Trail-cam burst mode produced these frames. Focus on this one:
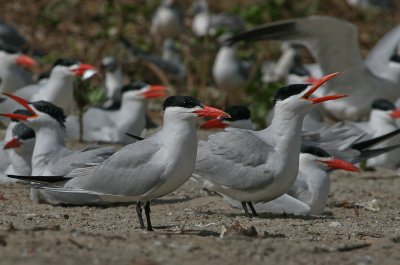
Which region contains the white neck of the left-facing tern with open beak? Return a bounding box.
[32,124,65,174]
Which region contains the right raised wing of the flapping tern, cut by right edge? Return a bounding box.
[366,26,400,81]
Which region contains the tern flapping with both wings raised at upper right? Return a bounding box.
[227,16,400,120]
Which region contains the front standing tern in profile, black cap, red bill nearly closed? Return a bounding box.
[8,96,228,231]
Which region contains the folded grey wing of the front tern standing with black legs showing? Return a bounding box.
[65,139,165,196]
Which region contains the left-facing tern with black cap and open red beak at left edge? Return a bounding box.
[0,94,113,176]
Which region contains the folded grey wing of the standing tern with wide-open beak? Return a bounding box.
[195,128,272,190]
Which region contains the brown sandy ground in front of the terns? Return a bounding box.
[0,163,400,265]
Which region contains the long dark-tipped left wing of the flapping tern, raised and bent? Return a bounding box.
[228,16,365,90]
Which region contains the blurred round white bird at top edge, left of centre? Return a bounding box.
[150,0,183,39]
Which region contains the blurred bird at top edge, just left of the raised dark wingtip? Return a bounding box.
[189,0,245,37]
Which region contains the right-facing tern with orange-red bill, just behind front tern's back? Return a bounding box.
[67,83,167,144]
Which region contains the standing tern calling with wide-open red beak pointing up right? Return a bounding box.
[195,73,345,214]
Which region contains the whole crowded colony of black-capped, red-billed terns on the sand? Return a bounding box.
[0,0,400,231]
